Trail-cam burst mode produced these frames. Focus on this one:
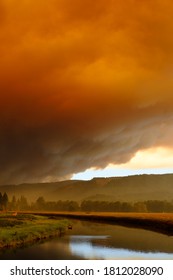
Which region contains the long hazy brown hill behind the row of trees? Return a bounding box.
[0,174,173,202]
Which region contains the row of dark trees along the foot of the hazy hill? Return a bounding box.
[0,193,173,213]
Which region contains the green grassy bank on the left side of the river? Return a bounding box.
[0,214,68,248]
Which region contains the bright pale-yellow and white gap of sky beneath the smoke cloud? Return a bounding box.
[72,147,173,180]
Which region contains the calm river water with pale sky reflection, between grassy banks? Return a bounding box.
[0,220,173,260]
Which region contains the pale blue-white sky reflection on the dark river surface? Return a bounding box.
[69,235,173,259]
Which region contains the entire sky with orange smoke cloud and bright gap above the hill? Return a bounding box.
[0,0,173,184]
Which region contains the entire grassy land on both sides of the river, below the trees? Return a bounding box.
[0,211,173,249]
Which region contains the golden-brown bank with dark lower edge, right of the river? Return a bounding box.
[21,212,173,236]
